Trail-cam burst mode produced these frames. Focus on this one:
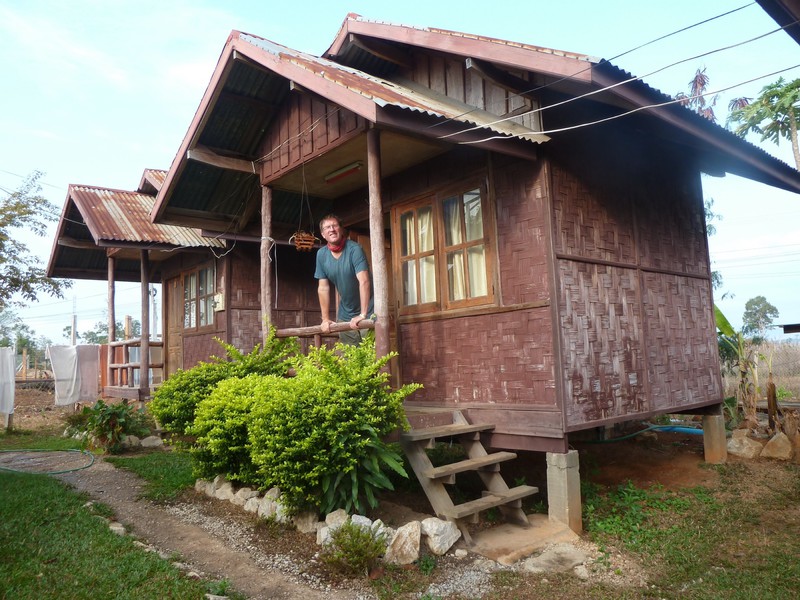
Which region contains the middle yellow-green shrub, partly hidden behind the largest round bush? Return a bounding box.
[189,375,282,483]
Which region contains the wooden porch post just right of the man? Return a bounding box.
[367,128,389,358]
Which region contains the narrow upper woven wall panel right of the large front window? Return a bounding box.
[494,162,550,304]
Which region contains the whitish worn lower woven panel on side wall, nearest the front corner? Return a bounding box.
[558,260,648,426]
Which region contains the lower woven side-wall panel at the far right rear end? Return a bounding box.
[642,273,722,410]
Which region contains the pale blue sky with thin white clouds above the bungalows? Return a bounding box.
[0,0,800,343]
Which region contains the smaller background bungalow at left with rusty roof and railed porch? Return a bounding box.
[47,169,234,400]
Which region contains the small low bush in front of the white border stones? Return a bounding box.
[320,520,387,577]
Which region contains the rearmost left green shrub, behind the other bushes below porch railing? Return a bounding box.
[149,328,299,434]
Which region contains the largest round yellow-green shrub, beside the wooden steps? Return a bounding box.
[249,337,420,512]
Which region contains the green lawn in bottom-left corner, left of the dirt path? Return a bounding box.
[0,472,207,600]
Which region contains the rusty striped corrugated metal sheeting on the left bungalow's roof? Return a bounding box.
[69,185,225,248]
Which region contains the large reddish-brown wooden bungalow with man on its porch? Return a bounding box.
[114,14,800,527]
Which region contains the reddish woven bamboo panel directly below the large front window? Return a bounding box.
[400,308,556,406]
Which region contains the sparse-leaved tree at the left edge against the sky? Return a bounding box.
[0,171,72,310]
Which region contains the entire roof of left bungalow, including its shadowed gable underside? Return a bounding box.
[47,179,225,281]
